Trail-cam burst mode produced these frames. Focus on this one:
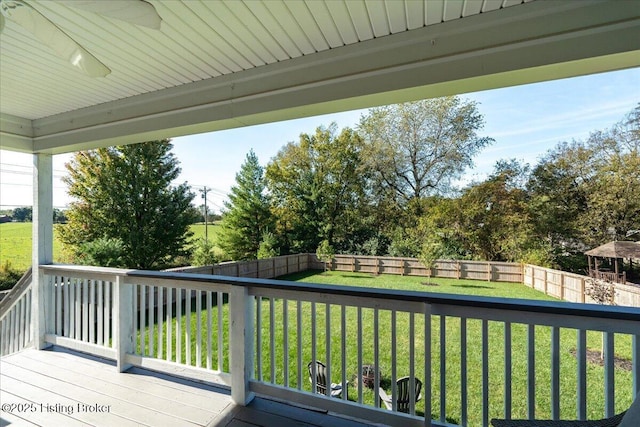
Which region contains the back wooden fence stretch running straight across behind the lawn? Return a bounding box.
[330,255,523,283]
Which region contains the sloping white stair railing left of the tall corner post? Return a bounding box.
[0,269,33,356]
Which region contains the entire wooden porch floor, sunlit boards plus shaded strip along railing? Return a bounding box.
[0,350,378,427]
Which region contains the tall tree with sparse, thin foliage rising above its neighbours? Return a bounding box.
[358,97,493,209]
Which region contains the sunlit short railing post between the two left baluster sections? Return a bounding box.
[113,276,134,372]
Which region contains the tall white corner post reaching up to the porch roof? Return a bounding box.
[31,154,53,350]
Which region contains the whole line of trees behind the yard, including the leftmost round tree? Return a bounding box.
[58,97,640,276]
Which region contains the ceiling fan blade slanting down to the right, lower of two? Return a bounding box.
[1,0,111,77]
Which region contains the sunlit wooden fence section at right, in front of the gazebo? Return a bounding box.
[523,264,640,307]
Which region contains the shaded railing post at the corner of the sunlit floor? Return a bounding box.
[229,286,254,406]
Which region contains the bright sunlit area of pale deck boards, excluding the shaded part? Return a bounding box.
[0,350,231,426]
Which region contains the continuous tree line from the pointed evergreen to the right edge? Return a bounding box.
[219,97,640,271]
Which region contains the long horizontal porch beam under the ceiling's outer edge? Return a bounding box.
[13,0,640,153]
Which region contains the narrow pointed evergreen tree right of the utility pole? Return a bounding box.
[218,150,273,260]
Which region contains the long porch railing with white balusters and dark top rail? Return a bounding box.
[36,266,640,426]
